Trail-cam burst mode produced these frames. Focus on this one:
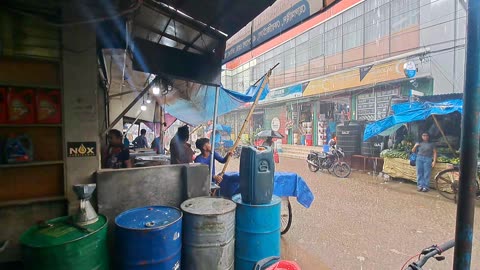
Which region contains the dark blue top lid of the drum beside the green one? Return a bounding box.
[115,206,182,230]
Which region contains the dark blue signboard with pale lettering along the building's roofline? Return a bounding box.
[224,0,323,63]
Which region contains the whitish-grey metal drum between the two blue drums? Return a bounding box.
[181,197,236,270]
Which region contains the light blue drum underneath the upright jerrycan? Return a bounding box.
[232,194,282,270]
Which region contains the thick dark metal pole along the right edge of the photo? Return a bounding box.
[453,1,480,270]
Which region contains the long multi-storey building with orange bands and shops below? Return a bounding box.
[221,0,466,145]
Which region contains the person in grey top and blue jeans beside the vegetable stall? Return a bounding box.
[412,132,437,192]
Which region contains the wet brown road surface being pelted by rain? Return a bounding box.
[222,158,480,270]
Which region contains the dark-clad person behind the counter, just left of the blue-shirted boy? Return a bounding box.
[170,125,194,164]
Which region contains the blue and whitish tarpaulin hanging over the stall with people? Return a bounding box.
[165,77,269,126]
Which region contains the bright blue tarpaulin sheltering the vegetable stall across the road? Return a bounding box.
[363,99,463,141]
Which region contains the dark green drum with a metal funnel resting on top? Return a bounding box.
[20,215,108,270]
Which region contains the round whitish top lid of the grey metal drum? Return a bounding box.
[180,197,237,216]
